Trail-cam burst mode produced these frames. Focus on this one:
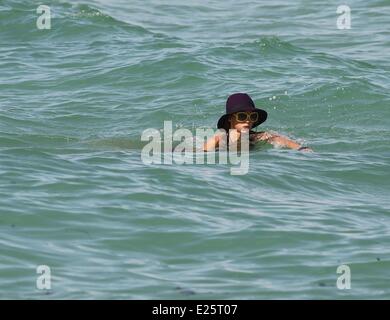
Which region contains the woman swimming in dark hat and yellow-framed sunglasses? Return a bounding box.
[203,93,313,152]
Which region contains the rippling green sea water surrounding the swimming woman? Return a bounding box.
[0,0,390,299]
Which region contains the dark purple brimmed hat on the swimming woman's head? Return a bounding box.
[217,93,267,131]
